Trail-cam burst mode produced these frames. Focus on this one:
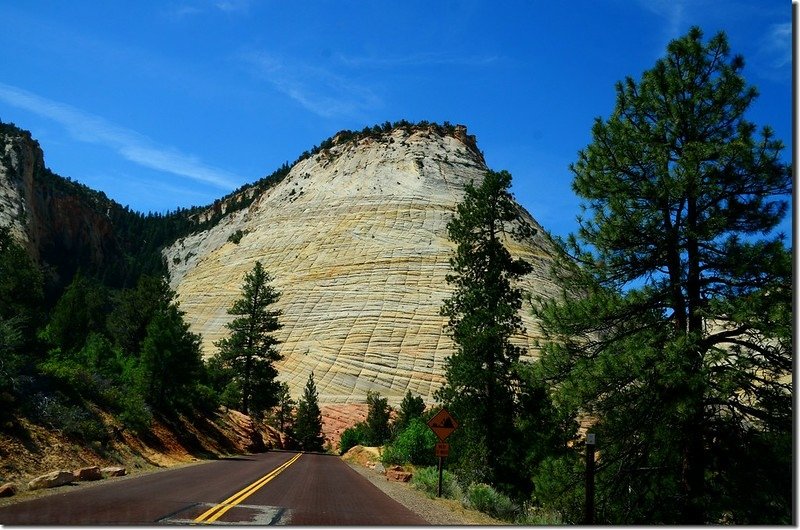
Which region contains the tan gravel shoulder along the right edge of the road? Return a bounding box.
[345,461,508,526]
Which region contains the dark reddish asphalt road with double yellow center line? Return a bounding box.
[0,452,426,525]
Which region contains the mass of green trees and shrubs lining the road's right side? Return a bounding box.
[336,28,793,524]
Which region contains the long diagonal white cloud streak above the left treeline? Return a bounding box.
[0,83,245,189]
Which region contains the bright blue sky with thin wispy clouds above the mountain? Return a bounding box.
[0,0,792,236]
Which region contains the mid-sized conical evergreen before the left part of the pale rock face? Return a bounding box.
[216,261,283,414]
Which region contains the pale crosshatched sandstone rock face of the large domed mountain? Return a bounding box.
[165,125,556,405]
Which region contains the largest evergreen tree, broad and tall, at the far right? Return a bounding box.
[539,28,792,524]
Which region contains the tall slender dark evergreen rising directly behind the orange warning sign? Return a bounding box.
[437,171,532,484]
